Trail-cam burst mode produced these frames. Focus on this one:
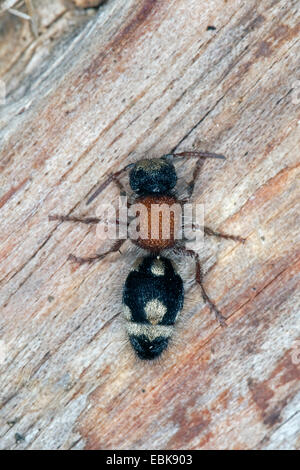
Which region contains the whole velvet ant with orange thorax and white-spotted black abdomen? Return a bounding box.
[49,152,245,360]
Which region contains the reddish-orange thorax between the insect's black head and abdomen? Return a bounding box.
[136,195,181,252]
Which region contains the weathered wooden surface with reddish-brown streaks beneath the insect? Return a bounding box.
[0,0,300,449]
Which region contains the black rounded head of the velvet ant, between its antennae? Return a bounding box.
[129,158,177,195]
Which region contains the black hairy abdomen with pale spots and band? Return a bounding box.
[123,256,184,359]
